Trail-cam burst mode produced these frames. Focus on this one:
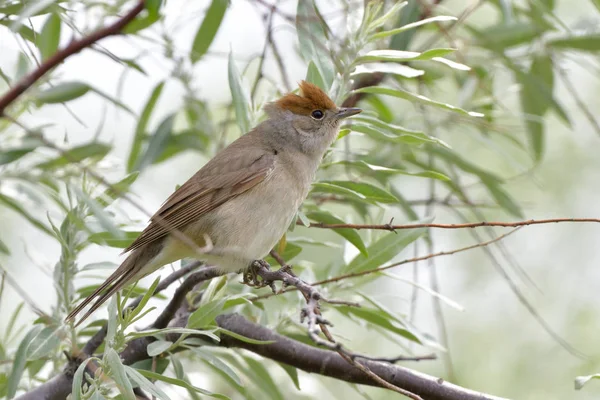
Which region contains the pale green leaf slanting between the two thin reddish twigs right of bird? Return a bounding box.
[344,220,427,272]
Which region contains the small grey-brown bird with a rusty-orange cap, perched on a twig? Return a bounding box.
[66,81,362,324]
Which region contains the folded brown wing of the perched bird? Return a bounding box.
[125,146,275,252]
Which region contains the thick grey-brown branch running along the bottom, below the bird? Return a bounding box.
[18,314,506,400]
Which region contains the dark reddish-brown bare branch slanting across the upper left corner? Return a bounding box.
[0,0,145,117]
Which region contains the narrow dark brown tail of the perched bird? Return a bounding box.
[65,251,147,326]
